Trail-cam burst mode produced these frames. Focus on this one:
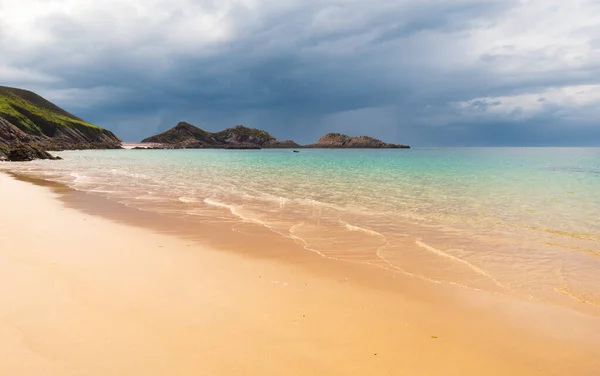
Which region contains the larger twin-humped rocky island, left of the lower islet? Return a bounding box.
[142,122,298,149]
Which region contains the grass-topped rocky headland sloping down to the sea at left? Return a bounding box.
[0,86,121,161]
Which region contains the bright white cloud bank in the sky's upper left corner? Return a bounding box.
[0,0,233,52]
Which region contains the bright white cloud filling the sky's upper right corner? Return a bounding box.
[468,0,600,76]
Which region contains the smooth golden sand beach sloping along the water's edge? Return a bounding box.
[0,174,600,376]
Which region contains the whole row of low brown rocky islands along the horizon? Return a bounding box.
[138,122,410,149]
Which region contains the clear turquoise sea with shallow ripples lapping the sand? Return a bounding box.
[1,148,600,310]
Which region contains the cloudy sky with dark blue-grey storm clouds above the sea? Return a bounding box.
[0,0,600,146]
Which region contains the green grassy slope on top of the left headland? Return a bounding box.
[0,87,101,135]
